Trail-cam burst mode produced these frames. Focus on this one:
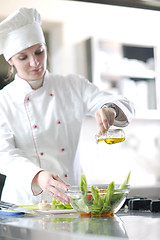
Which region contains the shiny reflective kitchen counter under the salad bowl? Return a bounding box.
[0,210,160,240]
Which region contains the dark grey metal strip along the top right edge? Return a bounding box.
[69,0,160,11]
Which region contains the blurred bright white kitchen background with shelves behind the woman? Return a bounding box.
[0,0,160,191]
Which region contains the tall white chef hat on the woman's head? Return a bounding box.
[0,8,45,61]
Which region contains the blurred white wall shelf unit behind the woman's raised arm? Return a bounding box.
[91,38,160,117]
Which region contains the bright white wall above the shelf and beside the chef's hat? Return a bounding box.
[0,0,160,74]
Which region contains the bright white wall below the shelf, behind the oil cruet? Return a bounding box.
[81,118,160,187]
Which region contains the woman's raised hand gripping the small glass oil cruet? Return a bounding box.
[95,108,116,135]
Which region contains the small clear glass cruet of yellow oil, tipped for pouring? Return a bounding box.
[95,129,125,144]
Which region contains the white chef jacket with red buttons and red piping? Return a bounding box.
[0,71,134,204]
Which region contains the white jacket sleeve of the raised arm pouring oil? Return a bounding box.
[77,77,135,127]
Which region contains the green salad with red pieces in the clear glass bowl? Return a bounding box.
[71,172,130,215]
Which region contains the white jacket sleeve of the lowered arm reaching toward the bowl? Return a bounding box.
[0,114,41,195]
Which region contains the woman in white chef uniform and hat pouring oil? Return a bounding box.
[0,8,134,204]
